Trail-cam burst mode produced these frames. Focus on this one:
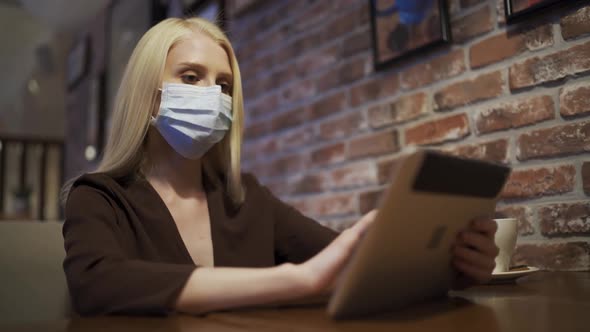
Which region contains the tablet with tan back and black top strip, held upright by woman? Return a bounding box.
[328,150,510,319]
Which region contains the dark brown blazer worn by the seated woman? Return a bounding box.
[63,173,337,315]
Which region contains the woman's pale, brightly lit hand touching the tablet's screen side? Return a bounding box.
[296,210,377,296]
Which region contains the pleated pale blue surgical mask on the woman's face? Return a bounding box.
[152,83,232,159]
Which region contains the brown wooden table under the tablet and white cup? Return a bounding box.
[0,272,590,332]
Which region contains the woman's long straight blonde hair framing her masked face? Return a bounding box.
[62,17,244,204]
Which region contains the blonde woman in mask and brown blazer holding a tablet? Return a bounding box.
[63,18,497,314]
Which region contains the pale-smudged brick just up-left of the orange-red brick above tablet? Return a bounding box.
[369,93,430,128]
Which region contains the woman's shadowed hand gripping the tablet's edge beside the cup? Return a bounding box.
[452,218,498,289]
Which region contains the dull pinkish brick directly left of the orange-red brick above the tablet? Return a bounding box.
[348,130,399,159]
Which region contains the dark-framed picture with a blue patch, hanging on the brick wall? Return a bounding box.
[369,0,452,70]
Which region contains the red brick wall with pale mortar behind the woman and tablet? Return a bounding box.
[230,0,590,270]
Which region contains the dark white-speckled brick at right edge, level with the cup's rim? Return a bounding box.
[539,202,590,236]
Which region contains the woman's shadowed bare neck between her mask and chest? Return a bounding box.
[144,129,204,197]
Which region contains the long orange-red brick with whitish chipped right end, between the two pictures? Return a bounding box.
[469,24,553,68]
